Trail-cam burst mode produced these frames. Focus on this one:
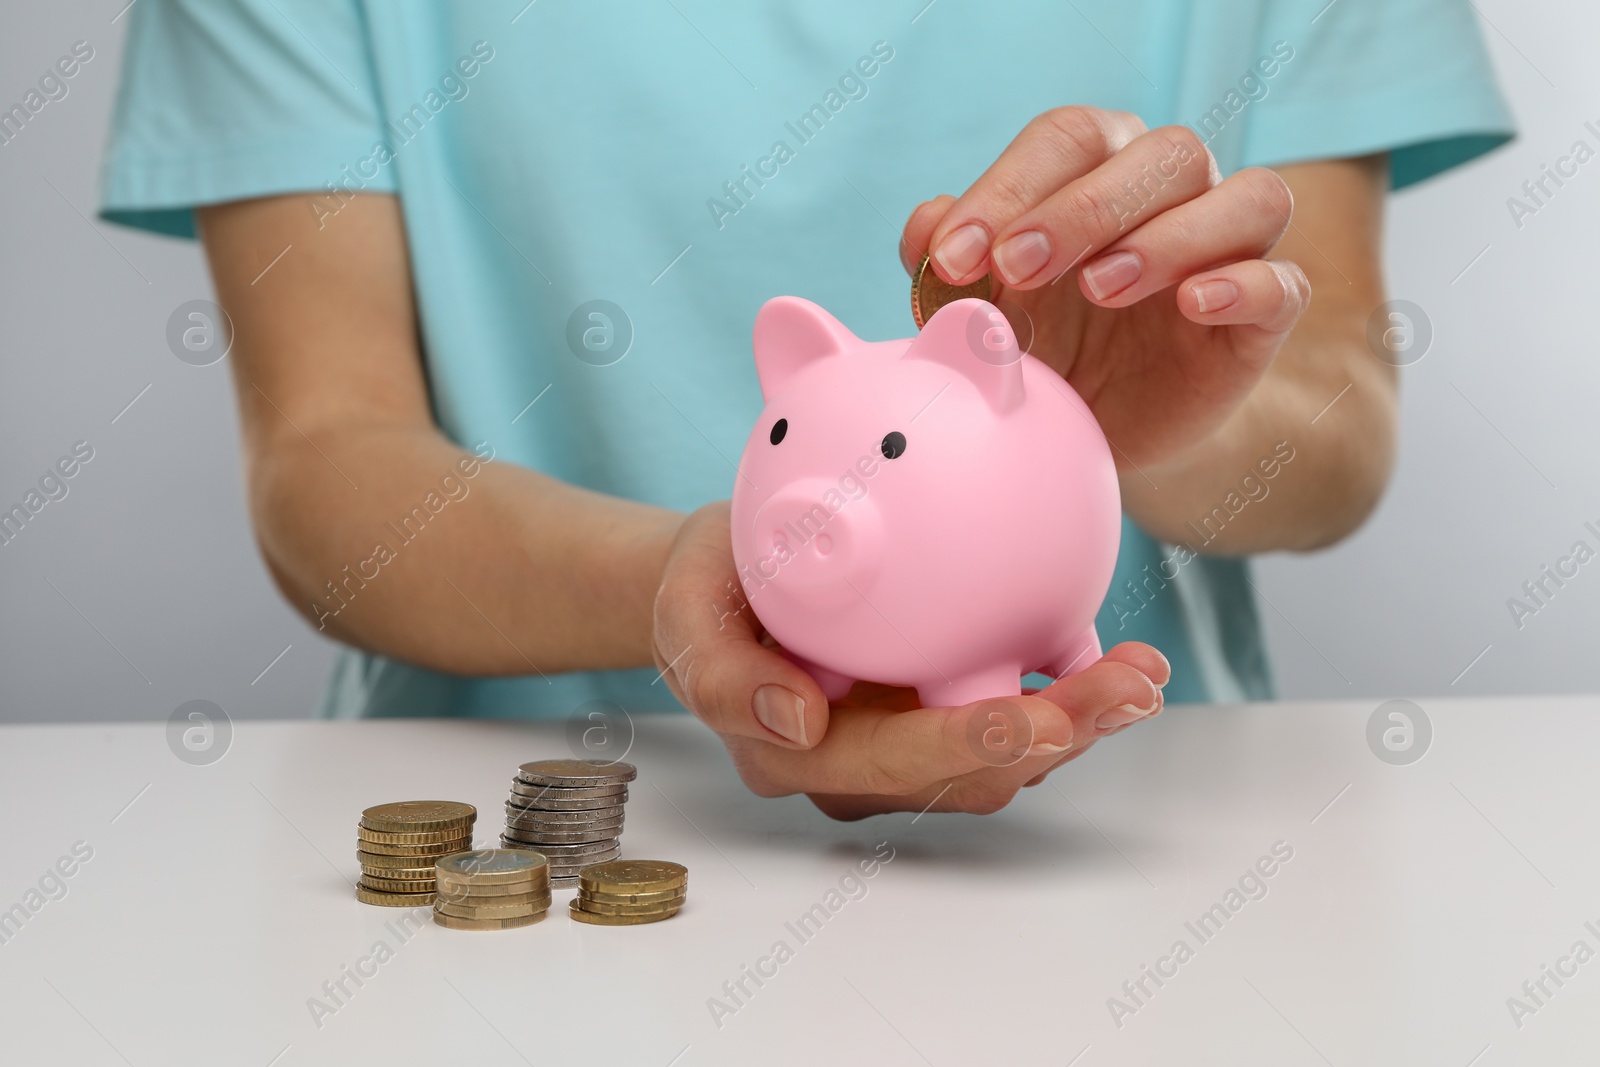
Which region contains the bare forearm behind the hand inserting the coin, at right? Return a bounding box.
[1122,328,1397,555]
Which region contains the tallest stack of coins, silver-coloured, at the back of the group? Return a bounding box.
[501,760,638,889]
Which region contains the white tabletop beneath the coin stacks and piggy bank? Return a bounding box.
[0,697,1600,1067]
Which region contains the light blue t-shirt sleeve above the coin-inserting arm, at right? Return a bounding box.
[1190,0,1515,189]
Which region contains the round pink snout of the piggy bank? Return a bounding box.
[752,478,883,600]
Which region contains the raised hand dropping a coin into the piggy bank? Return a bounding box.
[901,107,1310,469]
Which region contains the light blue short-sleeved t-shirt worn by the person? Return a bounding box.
[101,0,1510,717]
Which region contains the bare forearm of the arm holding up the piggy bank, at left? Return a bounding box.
[242,422,683,675]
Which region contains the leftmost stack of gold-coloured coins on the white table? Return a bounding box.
[355,800,478,907]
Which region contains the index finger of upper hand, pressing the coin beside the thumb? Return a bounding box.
[930,107,1144,285]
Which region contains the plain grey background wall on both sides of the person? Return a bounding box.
[0,0,1600,721]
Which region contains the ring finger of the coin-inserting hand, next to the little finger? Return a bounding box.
[1078,168,1294,307]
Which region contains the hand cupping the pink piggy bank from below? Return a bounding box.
[653,502,1171,819]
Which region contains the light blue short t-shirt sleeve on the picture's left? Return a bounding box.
[99,0,395,237]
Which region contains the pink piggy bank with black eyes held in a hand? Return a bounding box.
[733,296,1122,707]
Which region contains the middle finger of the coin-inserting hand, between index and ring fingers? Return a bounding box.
[994,126,1221,290]
